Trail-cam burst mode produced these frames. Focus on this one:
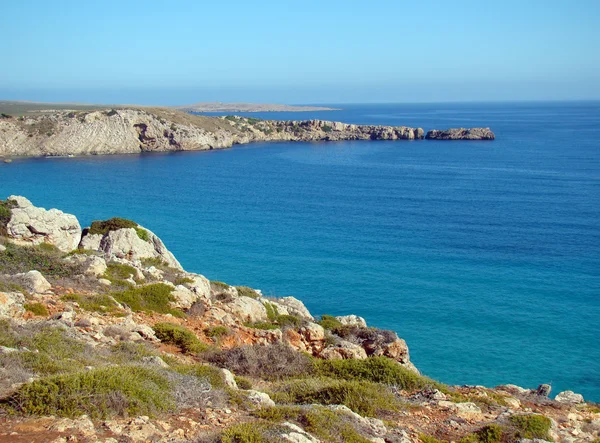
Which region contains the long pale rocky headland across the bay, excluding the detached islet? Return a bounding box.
[0,108,423,157]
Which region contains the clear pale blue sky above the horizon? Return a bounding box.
[0,0,600,105]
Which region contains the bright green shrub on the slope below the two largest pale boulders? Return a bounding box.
[112,283,180,317]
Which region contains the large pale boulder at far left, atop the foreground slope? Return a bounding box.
[6,195,81,252]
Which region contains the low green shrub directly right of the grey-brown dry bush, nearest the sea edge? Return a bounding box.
[313,357,440,391]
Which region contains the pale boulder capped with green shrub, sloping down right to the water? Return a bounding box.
[79,226,183,270]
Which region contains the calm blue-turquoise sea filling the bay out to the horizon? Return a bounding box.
[0,103,600,401]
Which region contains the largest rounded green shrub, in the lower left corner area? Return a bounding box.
[4,366,174,418]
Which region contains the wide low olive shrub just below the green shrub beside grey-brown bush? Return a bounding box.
[273,378,397,417]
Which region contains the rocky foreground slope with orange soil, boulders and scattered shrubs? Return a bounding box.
[0,196,600,443]
